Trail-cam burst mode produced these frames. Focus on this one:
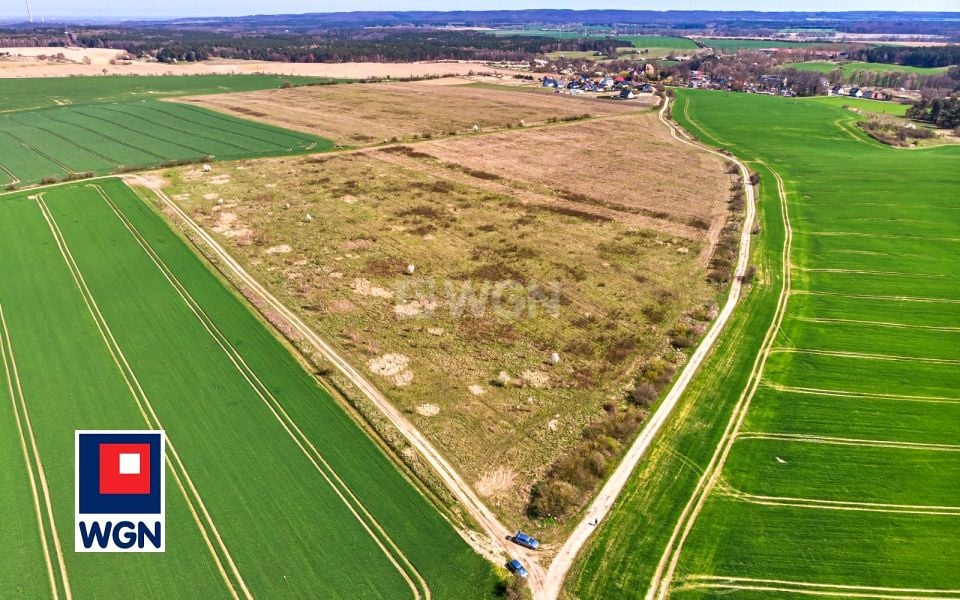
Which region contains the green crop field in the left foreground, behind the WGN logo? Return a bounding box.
[0,178,496,598]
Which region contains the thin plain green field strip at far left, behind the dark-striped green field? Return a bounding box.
[0,75,338,113]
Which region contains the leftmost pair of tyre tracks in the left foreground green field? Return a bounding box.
[0,306,73,600]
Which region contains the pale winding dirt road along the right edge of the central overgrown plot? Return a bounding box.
[533,101,756,599]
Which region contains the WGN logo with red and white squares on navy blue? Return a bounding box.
[74,431,165,552]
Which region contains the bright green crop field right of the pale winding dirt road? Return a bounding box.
[568,90,960,598]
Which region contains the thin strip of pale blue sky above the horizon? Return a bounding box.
[9,0,960,17]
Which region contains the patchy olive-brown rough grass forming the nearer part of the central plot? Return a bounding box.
[163,138,722,537]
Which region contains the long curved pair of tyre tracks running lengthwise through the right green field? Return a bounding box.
[646,162,793,600]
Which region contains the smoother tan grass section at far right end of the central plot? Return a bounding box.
[417,114,730,237]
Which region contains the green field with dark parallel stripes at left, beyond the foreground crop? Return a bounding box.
[0,100,331,184]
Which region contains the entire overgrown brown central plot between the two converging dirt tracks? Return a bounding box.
[163,104,731,535]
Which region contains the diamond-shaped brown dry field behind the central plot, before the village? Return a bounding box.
[179,82,644,146]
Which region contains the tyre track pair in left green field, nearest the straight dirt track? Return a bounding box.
[90,185,431,600]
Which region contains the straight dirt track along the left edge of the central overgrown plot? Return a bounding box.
[128,176,544,589]
